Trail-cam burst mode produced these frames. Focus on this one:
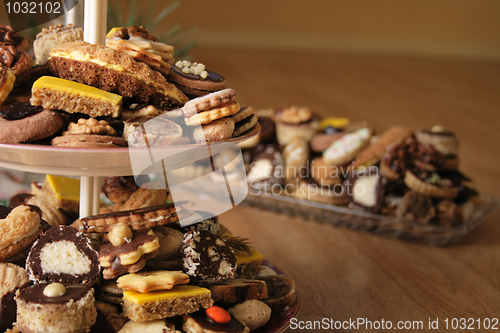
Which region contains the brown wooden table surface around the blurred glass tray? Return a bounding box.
[193,48,500,332]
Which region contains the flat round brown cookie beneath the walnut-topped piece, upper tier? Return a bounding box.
[52,134,127,148]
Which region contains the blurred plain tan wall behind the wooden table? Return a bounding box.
[163,0,500,60]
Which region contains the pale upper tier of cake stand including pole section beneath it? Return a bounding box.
[0,123,260,217]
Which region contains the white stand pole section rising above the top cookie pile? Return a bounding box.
[83,0,108,45]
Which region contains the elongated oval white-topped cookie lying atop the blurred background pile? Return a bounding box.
[323,127,372,166]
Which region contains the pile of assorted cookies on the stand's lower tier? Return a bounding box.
[0,175,297,333]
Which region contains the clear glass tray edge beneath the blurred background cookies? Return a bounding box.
[243,190,500,246]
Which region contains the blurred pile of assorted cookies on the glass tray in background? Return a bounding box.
[240,106,479,227]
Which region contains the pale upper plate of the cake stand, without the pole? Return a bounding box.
[0,123,260,177]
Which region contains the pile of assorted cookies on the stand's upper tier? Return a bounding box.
[0,24,257,148]
